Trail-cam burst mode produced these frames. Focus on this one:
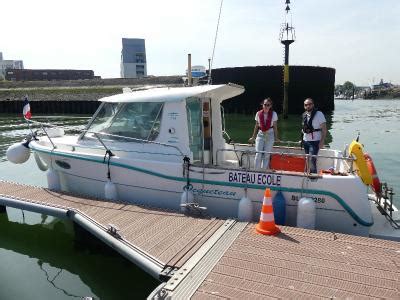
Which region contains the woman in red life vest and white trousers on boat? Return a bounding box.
[249,98,279,169]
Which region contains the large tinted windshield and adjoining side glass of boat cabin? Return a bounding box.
[86,102,163,141]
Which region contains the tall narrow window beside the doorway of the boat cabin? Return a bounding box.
[186,98,203,161]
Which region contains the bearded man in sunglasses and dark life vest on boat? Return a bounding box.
[302,98,326,173]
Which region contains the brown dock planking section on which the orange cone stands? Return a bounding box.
[193,224,400,299]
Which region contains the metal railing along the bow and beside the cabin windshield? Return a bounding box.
[26,119,185,158]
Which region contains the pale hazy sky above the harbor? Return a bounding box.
[0,0,400,86]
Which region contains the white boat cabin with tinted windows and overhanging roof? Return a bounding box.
[80,84,244,164]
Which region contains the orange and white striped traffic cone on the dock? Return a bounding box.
[256,188,281,235]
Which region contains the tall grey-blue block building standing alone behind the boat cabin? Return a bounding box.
[121,38,147,78]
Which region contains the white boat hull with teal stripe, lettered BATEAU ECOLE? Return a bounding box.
[34,147,373,236]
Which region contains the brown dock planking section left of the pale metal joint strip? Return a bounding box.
[0,181,224,268]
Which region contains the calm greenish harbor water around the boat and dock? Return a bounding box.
[0,100,400,299]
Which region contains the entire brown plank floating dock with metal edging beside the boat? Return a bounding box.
[0,181,400,299]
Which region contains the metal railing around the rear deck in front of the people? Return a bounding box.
[216,148,355,173]
